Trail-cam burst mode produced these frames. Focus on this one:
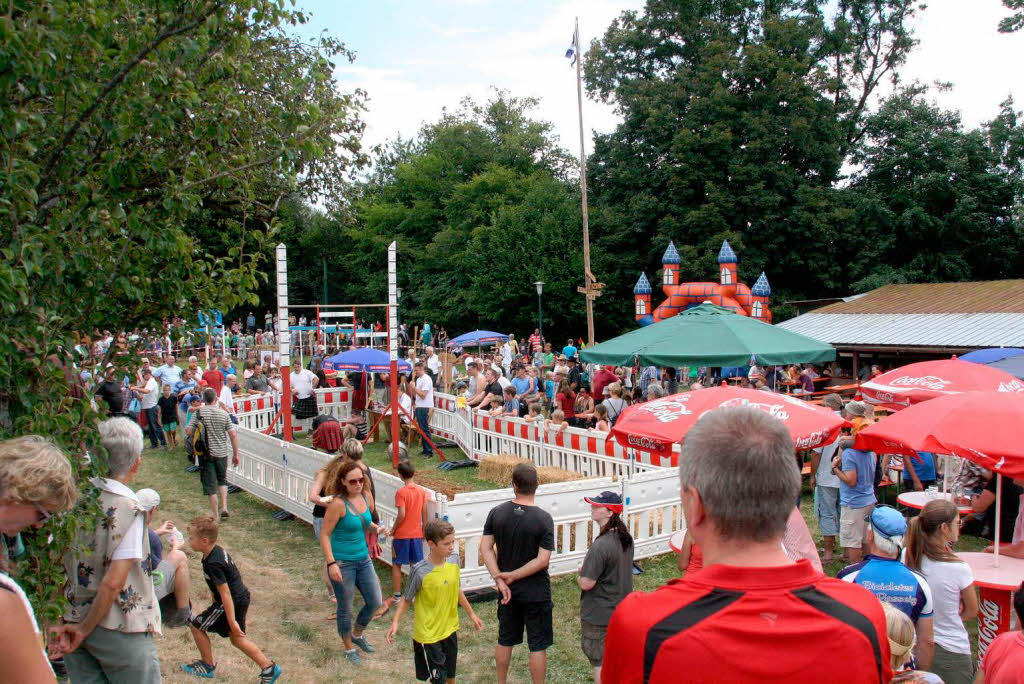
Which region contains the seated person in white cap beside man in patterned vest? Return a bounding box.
[135,488,191,627]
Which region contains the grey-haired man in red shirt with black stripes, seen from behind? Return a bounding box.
[601,407,892,684]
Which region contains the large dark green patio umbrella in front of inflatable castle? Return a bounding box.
[580,302,836,368]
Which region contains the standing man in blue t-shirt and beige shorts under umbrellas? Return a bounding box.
[831,438,878,563]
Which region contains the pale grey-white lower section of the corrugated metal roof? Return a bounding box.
[779,313,1024,347]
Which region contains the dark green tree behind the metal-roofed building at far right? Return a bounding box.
[849,88,1024,291]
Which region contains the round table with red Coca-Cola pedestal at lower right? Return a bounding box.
[956,545,1024,660]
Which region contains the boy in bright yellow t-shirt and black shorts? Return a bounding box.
[386,520,483,684]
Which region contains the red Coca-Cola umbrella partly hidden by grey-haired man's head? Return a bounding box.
[611,387,849,456]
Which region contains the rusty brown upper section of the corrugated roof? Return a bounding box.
[815,281,1024,313]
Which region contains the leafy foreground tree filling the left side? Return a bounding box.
[0,0,362,619]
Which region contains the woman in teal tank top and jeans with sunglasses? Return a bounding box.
[321,462,384,665]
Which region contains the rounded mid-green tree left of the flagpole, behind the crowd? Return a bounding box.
[337,92,583,333]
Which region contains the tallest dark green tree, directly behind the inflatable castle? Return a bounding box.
[585,0,918,329]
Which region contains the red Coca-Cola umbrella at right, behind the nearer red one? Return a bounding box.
[860,358,1024,411]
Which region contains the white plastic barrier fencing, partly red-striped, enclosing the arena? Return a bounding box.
[228,388,684,589]
